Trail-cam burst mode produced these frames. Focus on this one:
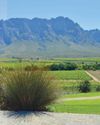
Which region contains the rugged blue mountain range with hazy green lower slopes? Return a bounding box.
[0,16,100,58]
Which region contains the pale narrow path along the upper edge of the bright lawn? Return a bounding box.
[59,96,100,102]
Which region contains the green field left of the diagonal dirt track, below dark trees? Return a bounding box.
[50,70,92,80]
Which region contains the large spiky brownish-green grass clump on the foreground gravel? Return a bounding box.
[0,70,58,111]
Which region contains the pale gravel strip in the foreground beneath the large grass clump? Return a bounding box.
[0,111,100,125]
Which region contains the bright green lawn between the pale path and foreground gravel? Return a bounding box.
[49,99,100,114]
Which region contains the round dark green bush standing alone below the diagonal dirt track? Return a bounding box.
[78,80,91,93]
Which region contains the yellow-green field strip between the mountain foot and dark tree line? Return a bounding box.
[0,57,100,68]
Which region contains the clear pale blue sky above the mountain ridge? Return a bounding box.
[0,0,100,30]
